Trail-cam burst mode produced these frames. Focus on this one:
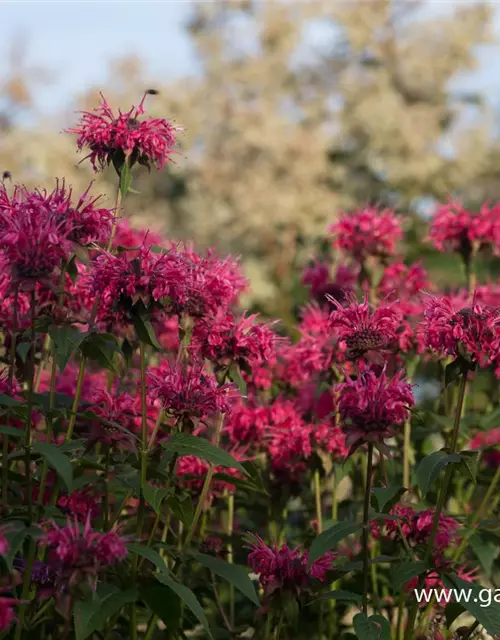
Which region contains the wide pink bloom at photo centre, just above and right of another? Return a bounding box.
[190,312,277,367]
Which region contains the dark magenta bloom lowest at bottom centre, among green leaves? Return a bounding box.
[248,535,335,598]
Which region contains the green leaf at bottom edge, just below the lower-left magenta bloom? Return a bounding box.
[74,587,139,640]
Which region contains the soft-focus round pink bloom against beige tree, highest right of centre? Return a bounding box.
[330,207,403,262]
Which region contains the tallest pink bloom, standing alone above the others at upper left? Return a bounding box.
[67,91,181,171]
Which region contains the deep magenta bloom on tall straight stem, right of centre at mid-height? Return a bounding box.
[335,369,415,451]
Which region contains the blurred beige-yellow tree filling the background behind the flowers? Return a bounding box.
[0,0,500,314]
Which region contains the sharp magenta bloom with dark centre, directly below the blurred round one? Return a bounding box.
[330,296,401,359]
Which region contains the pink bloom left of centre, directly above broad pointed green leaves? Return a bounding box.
[147,362,234,417]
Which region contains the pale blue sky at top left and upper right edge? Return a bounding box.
[0,0,500,114]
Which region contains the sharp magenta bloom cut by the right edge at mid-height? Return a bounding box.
[423,295,500,367]
